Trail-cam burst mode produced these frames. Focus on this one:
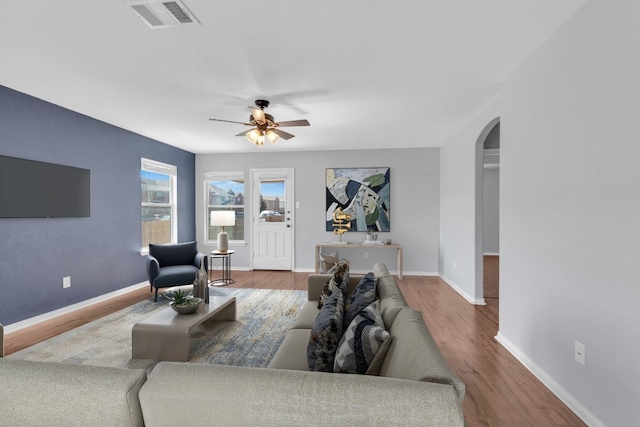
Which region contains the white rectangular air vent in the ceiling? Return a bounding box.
[124,0,200,29]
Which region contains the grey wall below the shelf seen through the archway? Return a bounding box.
[482,165,500,255]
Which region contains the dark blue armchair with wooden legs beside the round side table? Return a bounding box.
[147,242,209,301]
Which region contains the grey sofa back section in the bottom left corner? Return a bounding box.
[0,358,147,427]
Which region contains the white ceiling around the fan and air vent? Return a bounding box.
[0,0,586,153]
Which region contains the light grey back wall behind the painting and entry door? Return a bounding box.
[196,147,440,275]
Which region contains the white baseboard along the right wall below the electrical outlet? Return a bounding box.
[495,331,606,427]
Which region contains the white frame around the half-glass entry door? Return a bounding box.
[251,168,296,271]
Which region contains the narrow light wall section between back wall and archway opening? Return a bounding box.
[440,101,499,304]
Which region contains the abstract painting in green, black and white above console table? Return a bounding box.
[325,167,391,232]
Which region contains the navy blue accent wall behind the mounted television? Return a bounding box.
[0,86,195,325]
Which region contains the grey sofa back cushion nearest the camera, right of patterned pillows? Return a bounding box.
[380,307,465,402]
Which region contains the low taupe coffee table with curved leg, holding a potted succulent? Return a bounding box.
[131,296,236,362]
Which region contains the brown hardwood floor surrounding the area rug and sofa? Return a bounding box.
[5,263,585,427]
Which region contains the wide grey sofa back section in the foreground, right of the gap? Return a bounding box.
[140,362,464,427]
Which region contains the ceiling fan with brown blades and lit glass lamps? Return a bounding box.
[209,99,310,147]
